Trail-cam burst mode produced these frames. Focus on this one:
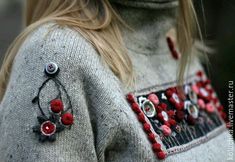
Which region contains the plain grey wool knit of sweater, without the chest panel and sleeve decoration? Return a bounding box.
[0,1,234,162]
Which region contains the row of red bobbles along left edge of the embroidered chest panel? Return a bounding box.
[127,93,166,159]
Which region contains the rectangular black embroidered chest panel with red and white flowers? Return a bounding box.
[127,71,226,159]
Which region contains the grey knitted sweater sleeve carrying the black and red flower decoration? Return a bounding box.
[0,22,97,162]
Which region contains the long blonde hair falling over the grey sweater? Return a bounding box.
[0,0,196,101]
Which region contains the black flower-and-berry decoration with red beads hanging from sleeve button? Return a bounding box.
[32,62,74,142]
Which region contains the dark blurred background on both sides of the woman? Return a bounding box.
[0,0,235,132]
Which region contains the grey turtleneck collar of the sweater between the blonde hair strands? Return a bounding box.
[112,0,178,55]
